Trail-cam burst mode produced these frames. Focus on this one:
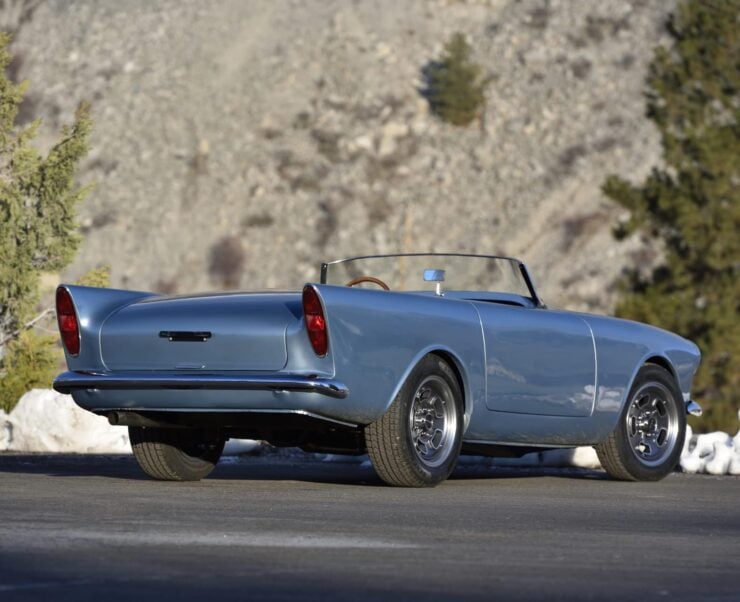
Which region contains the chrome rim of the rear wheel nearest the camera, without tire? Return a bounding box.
[409,374,458,468]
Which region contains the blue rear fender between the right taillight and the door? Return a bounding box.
[315,285,485,424]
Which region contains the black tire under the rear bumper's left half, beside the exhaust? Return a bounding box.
[128,426,225,481]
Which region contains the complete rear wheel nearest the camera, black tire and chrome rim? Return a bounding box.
[365,355,463,487]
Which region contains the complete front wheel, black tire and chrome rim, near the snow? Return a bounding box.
[596,364,686,481]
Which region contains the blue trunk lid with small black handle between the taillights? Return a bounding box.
[100,293,302,371]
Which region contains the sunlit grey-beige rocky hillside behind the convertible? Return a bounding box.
[8,0,673,311]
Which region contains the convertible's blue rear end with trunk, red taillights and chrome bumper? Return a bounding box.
[54,285,351,423]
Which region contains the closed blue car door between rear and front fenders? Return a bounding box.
[475,302,596,416]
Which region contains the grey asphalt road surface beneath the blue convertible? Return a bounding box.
[0,454,740,602]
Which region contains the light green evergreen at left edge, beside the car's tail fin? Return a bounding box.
[0,33,91,408]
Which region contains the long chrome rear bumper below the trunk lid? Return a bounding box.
[54,372,349,399]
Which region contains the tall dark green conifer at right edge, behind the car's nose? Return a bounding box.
[603,0,740,432]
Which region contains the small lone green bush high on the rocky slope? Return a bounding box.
[424,32,486,125]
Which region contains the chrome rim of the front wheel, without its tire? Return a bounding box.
[625,382,680,466]
